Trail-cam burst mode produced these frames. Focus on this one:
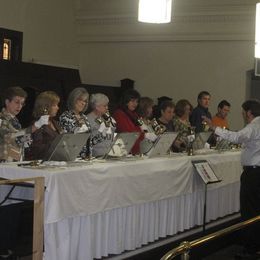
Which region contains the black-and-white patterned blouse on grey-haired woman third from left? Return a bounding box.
[59,110,92,158]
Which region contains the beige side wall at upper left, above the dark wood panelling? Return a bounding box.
[0,0,79,67]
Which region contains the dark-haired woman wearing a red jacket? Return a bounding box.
[113,89,144,155]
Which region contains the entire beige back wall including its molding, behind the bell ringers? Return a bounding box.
[76,0,257,129]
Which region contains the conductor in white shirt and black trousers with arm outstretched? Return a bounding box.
[208,100,260,259]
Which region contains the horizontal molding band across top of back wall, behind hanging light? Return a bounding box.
[75,3,255,43]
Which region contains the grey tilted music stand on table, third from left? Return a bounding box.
[142,132,178,158]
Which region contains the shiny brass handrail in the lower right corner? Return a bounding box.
[161,215,260,260]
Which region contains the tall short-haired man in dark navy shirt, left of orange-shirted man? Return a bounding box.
[190,91,211,133]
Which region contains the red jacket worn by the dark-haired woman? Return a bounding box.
[113,108,144,154]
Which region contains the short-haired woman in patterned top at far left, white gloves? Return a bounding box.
[0,87,48,162]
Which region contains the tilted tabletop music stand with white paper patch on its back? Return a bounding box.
[104,132,140,159]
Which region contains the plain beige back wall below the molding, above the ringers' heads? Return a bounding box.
[80,41,253,129]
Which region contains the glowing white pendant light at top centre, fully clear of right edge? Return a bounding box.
[138,0,172,23]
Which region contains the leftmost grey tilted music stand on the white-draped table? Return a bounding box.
[43,133,90,162]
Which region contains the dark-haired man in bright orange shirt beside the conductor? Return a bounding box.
[212,100,231,129]
